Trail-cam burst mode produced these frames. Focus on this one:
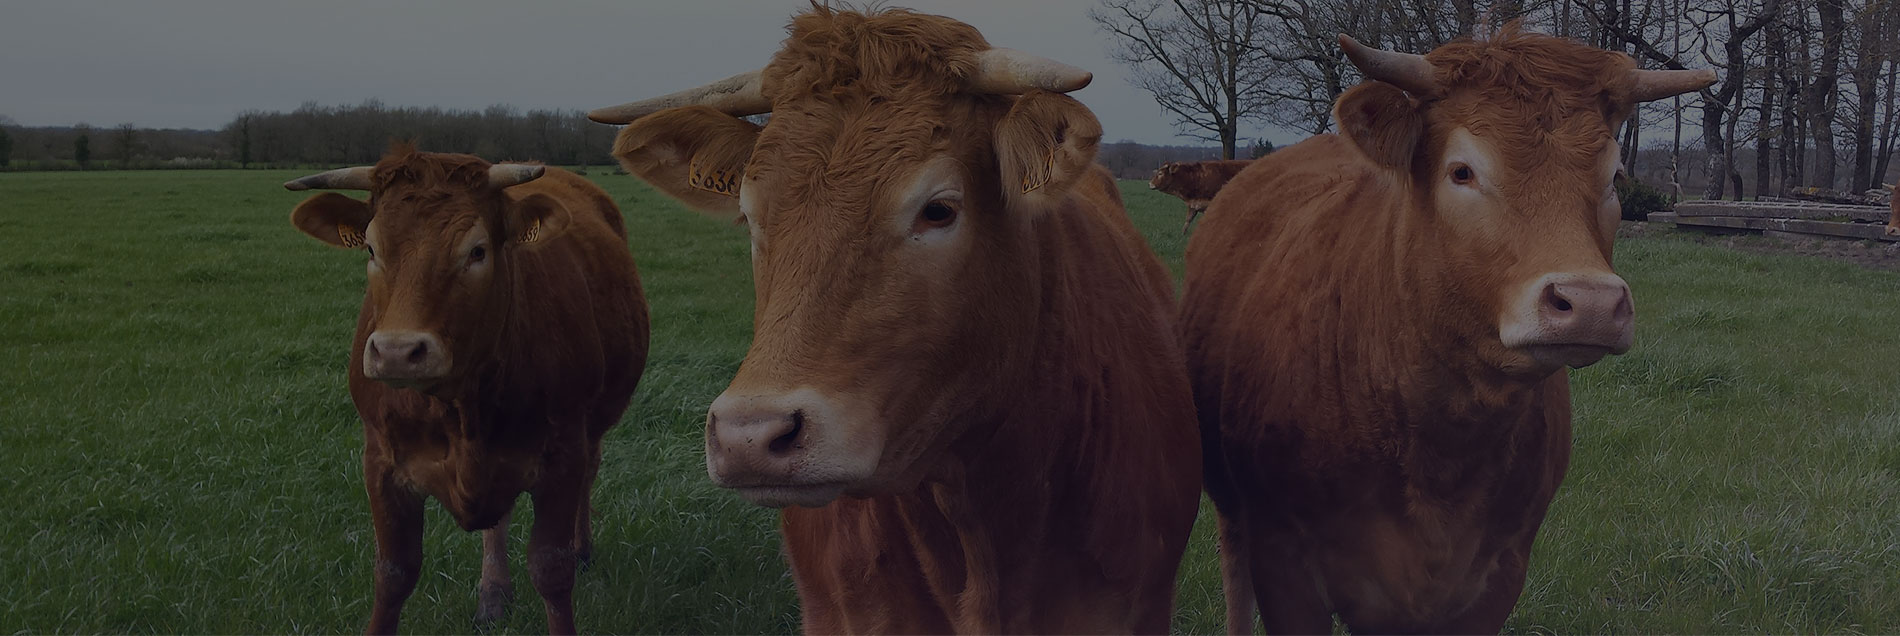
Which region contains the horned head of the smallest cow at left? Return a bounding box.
[283,146,568,391]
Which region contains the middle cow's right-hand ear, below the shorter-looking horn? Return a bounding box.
[996,91,1102,203]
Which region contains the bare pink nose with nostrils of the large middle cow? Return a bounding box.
[707,393,815,488]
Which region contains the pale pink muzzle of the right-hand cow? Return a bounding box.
[1497,273,1636,368]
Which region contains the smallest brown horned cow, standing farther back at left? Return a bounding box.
[285,146,648,632]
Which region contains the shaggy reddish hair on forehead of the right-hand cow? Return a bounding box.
[1425,21,1636,179]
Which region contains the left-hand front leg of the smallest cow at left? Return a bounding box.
[363,463,422,634]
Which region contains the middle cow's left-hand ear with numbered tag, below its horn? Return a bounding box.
[614,106,758,220]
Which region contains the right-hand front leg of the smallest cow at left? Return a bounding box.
[528,473,583,634]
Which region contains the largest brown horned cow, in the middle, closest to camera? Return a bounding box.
[591,8,1201,634]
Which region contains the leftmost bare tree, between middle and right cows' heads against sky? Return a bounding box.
[1089,0,1271,159]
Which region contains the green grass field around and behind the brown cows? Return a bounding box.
[0,171,1900,634]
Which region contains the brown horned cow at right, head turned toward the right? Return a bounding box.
[1182,27,1714,634]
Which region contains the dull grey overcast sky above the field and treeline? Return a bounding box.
[0,0,1290,144]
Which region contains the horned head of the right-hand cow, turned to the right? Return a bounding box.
[1334,25,1716,376]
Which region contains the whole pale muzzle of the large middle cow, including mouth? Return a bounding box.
[707,389,884,507]
